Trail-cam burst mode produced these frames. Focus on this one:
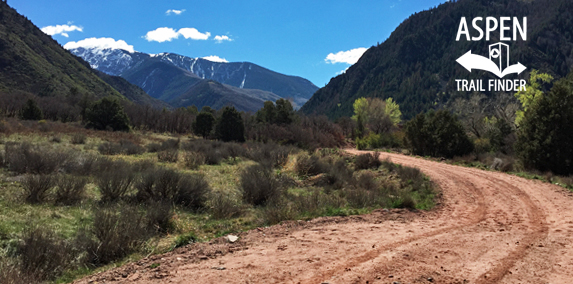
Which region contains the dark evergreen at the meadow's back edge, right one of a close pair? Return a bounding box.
[216,106,245,142]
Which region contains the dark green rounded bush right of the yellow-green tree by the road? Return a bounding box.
[405,110,474,158]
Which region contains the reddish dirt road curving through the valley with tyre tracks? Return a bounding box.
[78,150,573,284]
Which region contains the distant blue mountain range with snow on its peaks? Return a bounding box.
[70,47,318,106]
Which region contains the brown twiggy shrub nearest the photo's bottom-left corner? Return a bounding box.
[18,228,73,280]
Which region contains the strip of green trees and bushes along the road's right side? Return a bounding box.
[344,70,573,191]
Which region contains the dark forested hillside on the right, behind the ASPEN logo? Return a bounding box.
[301,0,573,119]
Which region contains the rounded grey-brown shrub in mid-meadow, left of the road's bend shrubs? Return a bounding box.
[240,165,283,206]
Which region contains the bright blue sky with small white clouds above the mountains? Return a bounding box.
[8,0,445,87]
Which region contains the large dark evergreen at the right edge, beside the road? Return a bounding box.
[515,73,573,175]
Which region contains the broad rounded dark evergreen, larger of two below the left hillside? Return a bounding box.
[86,97,129,131]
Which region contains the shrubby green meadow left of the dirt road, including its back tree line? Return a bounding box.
[0,96,437,283]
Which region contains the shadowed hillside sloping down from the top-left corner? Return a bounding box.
[0,2,156,104]
